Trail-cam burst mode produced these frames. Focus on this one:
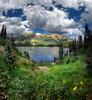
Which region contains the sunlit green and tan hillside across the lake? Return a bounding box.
[16,33,68,46]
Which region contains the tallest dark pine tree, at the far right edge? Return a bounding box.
[84,24,92,75]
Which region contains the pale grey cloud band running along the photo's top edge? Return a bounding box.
[1,0,81,9]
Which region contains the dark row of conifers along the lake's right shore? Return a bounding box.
[59,24,92,66]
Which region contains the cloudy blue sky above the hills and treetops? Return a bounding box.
[0,0,92,36]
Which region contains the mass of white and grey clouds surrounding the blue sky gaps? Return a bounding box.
[0,0,92,34]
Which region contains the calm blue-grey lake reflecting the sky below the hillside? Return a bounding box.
[17,46,68,63]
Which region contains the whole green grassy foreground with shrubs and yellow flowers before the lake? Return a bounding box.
[0,41,92,100]
